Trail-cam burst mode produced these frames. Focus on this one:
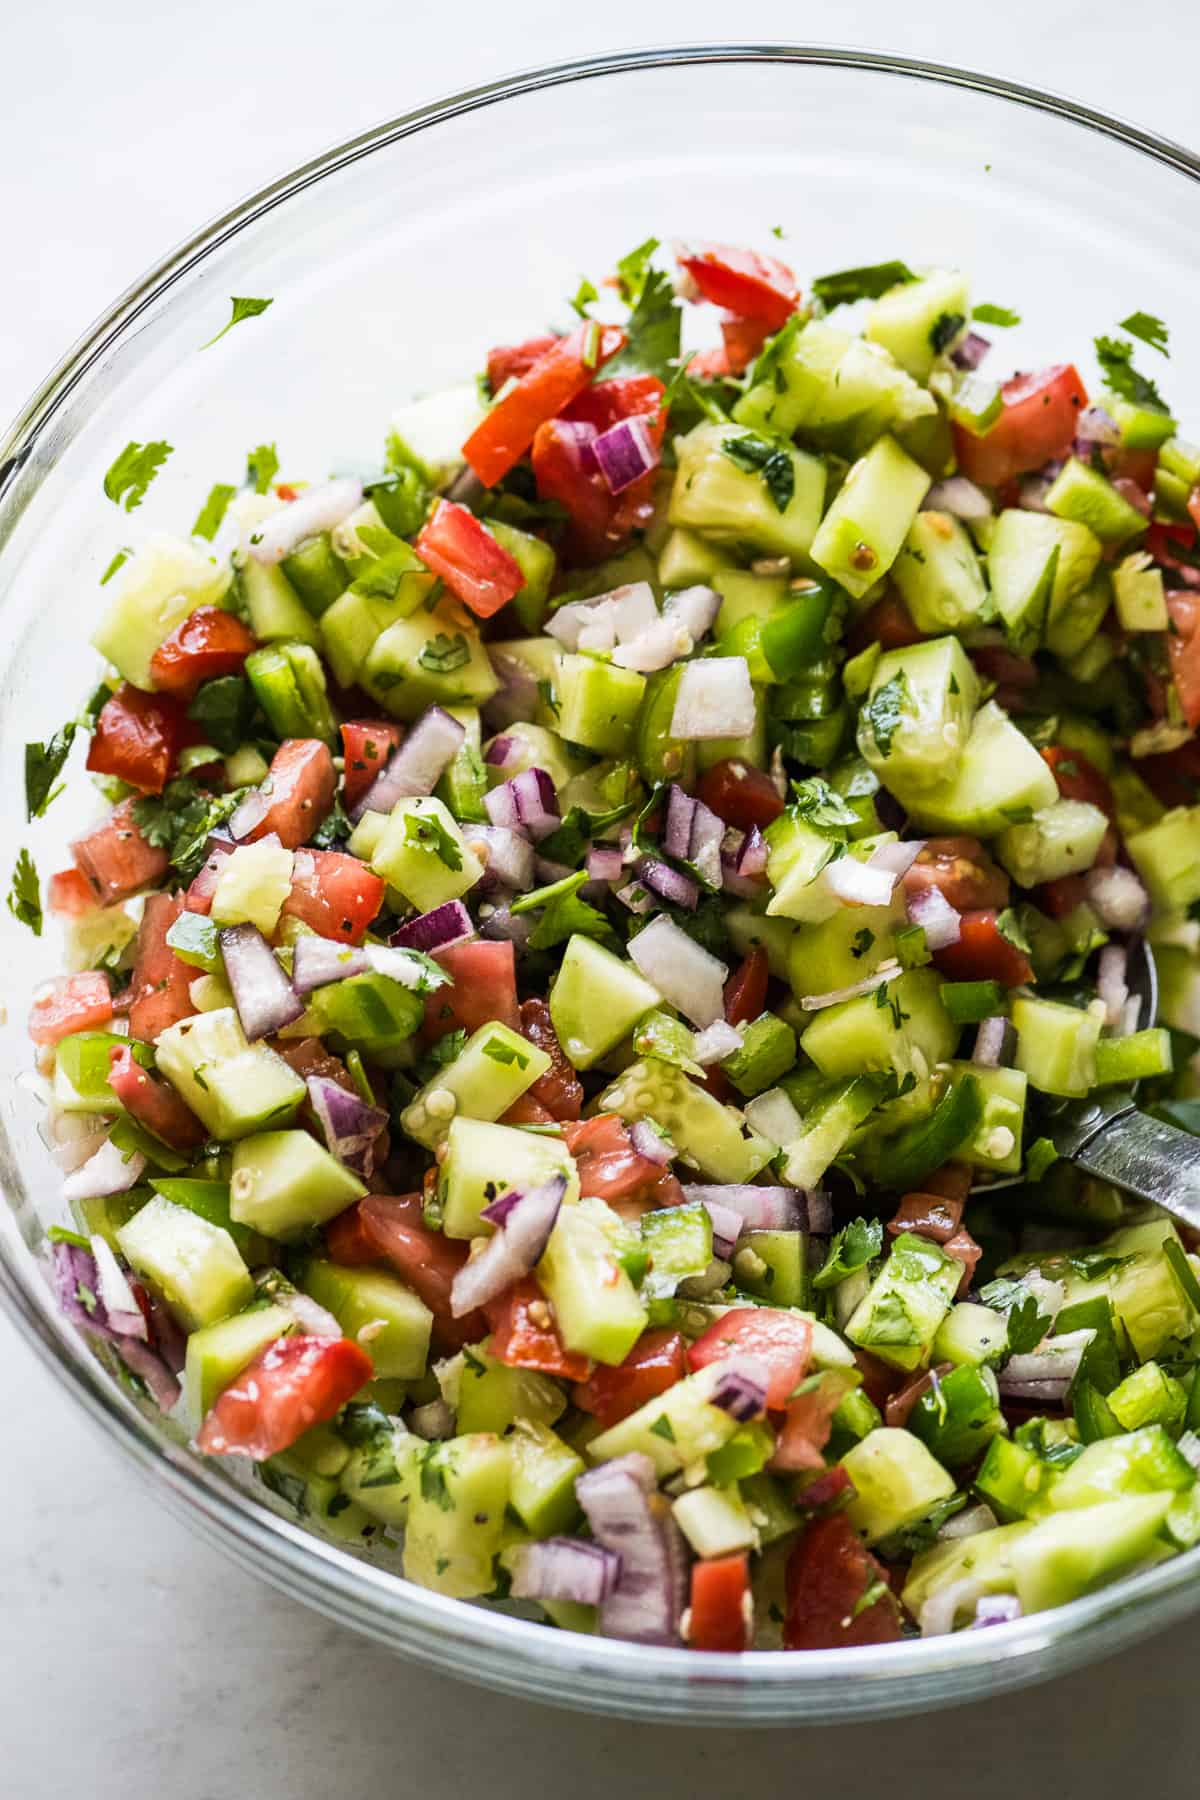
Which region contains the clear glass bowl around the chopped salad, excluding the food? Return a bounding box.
[0,45,1200,1724]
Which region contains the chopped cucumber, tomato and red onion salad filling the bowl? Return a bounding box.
[21,239,1200,1651]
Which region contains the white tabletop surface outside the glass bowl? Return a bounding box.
[0,0,1200,1800]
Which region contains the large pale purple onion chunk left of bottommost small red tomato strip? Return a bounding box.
[576,1451,684,1643]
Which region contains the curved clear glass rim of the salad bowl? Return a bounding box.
[9,41,1200,1724]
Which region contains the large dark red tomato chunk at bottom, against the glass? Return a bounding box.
[783,1512,900,1651]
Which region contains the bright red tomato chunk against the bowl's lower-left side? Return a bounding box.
[196,1336,374,1462]
